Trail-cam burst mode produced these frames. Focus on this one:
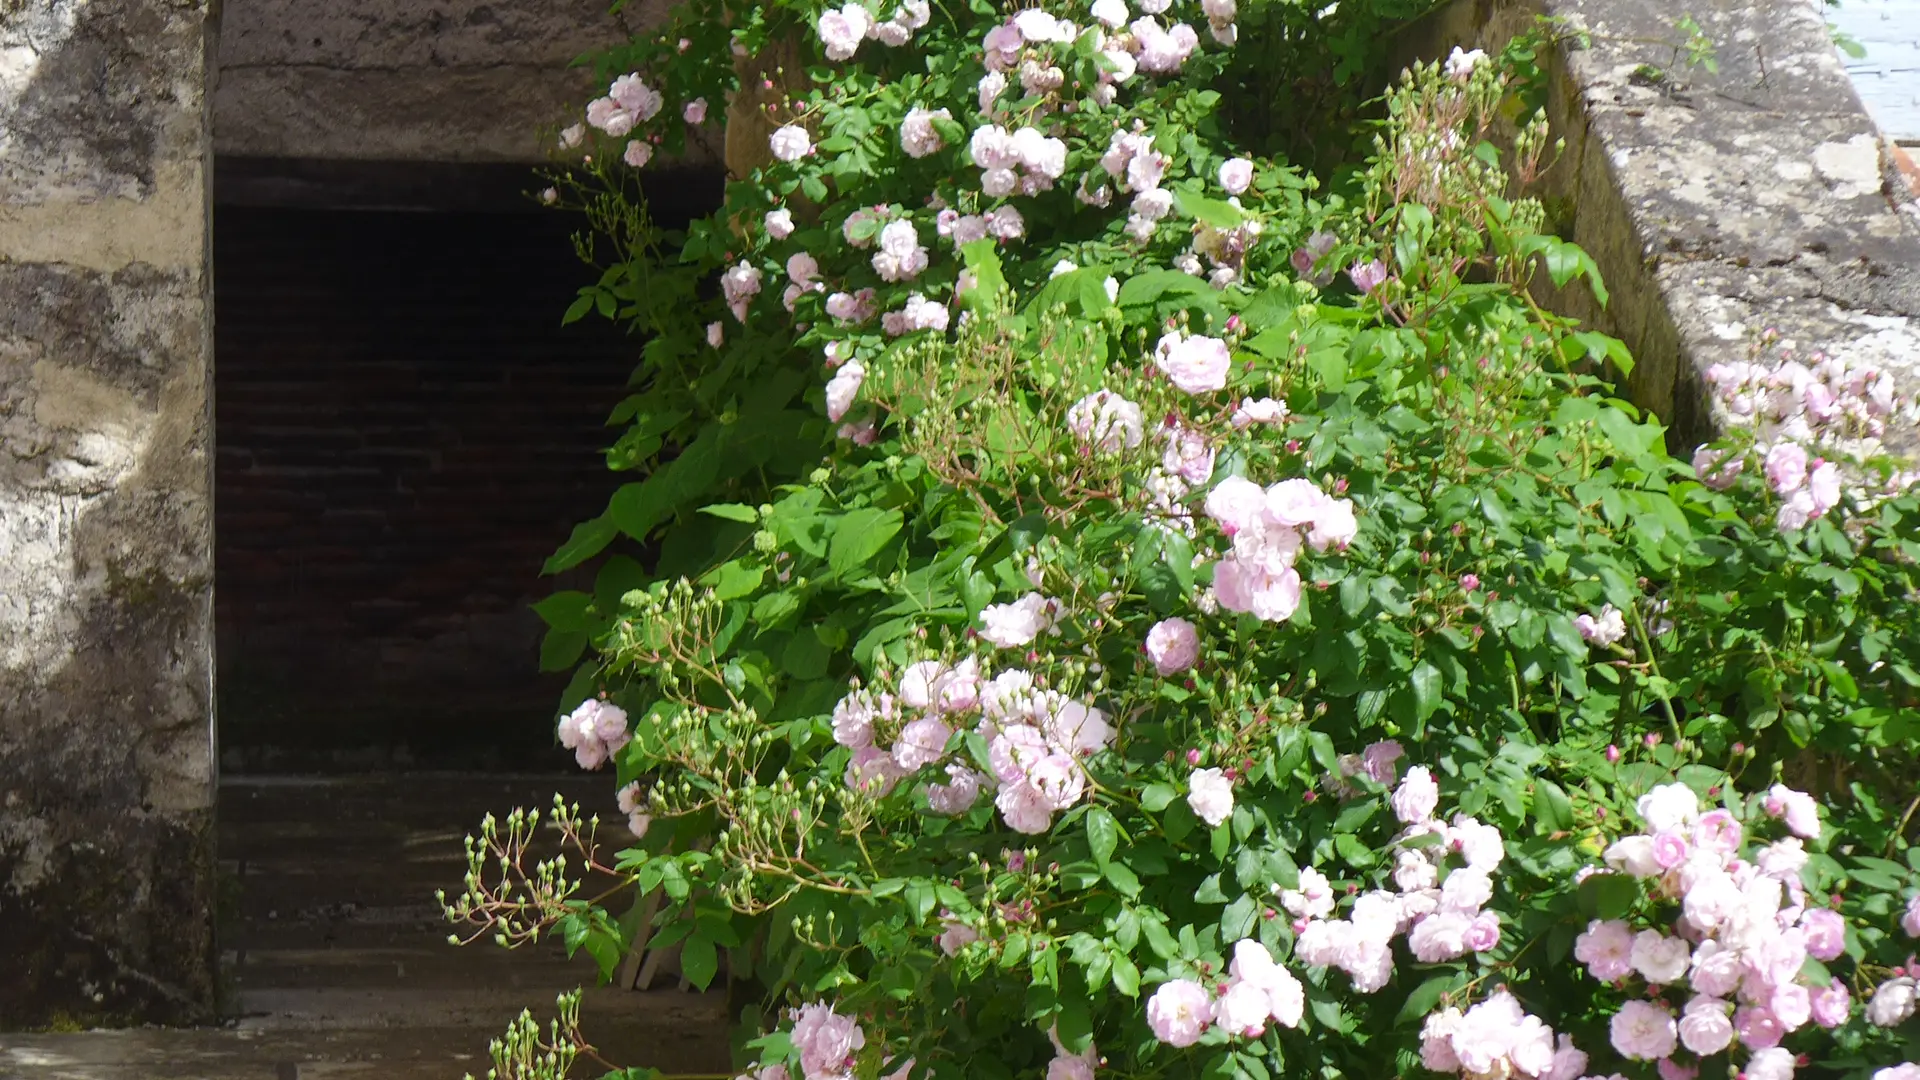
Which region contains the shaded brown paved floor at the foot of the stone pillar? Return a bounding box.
[0,774,728,1080]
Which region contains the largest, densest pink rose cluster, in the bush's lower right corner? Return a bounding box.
[1574,784,1851,1076]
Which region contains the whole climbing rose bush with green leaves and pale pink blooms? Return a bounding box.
[447,0,1920,1080]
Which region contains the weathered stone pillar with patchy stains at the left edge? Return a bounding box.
[0,0,215,1028]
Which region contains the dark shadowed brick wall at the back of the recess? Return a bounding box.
[213,208,637,769]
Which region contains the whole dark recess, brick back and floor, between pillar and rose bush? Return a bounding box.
[196,161,728,1080]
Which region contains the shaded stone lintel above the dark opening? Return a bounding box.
[213,0,683,161]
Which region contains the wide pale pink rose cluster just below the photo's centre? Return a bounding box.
[833,645,1114,834]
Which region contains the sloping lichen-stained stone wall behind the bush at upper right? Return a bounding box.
[1419,0,1920,457]
